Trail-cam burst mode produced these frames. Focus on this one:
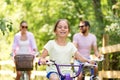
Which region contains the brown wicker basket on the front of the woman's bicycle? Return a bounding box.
[15,54,34,71]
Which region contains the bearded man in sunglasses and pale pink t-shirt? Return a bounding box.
[73,21,101,80]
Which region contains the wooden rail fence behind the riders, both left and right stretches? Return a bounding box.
[0,44,120,80]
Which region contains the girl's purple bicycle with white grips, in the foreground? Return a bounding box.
[38,54,103,80]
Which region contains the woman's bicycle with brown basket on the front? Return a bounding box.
[14,53,39,80]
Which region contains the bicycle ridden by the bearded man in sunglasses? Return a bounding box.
[82,55,104,80]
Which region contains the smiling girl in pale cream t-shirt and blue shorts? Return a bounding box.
[40,19,92,80]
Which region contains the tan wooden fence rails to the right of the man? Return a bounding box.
[99,44,120,80]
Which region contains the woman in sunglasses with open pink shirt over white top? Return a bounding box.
[12,21,37,80]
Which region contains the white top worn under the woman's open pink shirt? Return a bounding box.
[16,39,30,54]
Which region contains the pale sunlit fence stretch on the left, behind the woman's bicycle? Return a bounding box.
[0,60,47,80]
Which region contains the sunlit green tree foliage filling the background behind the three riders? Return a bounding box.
[0,0,120,76]
